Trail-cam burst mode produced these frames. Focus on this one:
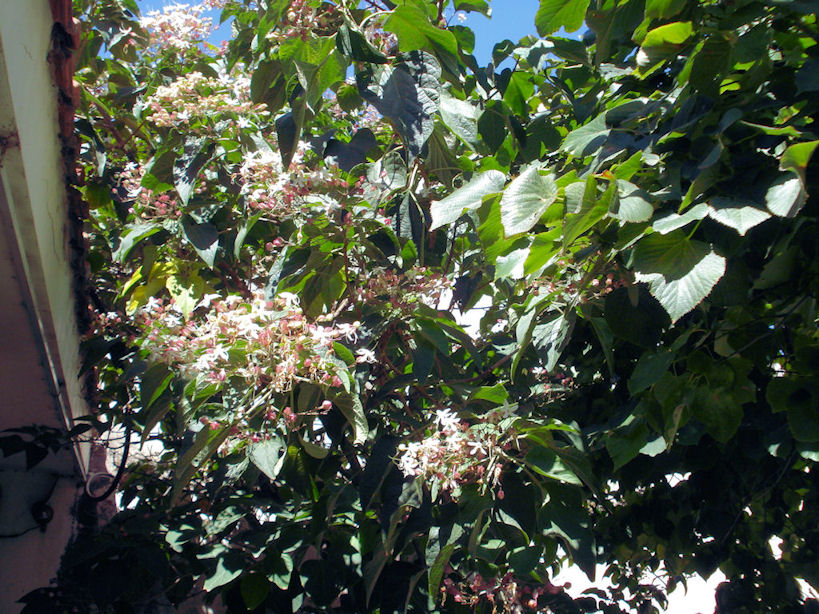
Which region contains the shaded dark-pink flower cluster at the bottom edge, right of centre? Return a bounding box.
[441,572,562,614]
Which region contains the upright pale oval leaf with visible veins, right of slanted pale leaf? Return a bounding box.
[500,165,557,236]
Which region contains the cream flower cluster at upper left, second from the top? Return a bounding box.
[145,71,268,130]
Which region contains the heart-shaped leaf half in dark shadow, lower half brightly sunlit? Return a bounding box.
[633,230,726,323]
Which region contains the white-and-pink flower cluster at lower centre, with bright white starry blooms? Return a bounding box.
[397,407,514,499]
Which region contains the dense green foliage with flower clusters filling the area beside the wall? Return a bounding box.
[14,0,819,613]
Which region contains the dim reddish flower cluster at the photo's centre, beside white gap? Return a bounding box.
[358,267,452,315]
